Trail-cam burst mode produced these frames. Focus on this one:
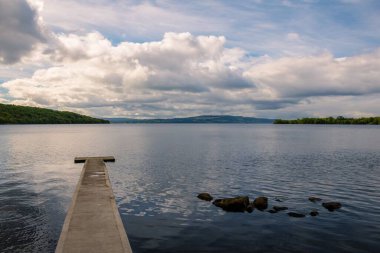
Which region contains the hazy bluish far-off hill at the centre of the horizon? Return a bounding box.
[107,115,273,124]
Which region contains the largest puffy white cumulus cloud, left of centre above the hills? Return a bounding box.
[2,32,254,116]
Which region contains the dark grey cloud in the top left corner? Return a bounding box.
[0,0,46,64]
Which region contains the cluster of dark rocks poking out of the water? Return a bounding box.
[197,192,342,218]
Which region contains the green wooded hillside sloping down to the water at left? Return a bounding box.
[0,104,109,124]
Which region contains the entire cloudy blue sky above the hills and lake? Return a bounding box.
[0,0,380,119]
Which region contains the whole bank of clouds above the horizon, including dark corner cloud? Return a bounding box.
[0,0,380,117]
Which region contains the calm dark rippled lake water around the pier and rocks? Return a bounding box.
[0,125,380,253]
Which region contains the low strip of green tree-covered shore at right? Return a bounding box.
[273,116,380,125]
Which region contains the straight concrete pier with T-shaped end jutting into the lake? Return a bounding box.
[55,157,132,253]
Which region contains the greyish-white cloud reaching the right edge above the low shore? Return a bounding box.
[246,49,380,99]
